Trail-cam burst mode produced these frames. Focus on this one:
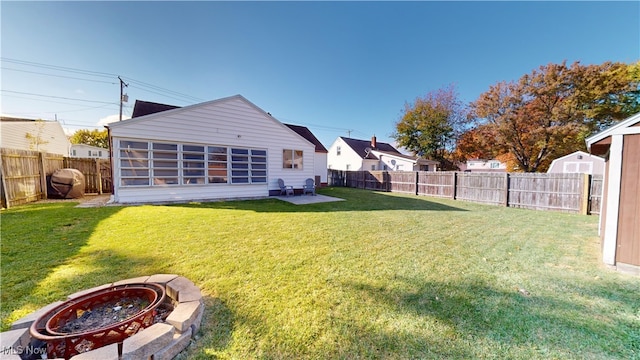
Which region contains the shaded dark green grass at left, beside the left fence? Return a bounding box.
[0,202,120,330]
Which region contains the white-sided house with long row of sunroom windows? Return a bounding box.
[108,95,316,203]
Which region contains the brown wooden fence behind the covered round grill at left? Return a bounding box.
[0,148,112,208]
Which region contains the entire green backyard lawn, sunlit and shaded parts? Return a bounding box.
[1,188,640,359]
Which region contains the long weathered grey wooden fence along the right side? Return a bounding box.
[329,170,602,214]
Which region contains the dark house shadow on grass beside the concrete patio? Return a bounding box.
[172,188,467,213]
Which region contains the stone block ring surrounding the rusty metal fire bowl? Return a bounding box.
[1,274,204,360]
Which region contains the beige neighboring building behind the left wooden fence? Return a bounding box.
[0,116,71,156]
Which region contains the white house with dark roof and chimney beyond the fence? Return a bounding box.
[327,136,438,171]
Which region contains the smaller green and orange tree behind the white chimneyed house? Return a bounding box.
[392,86,466,162]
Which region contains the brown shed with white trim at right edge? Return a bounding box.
[586,113,640,275]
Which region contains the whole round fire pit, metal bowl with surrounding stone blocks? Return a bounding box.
[0,274,204,360]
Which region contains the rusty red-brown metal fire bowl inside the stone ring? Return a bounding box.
[30,283,168,359]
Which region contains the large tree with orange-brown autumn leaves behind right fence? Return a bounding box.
[468,62,640,172]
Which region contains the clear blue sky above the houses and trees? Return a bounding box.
[0,1,640,147]
